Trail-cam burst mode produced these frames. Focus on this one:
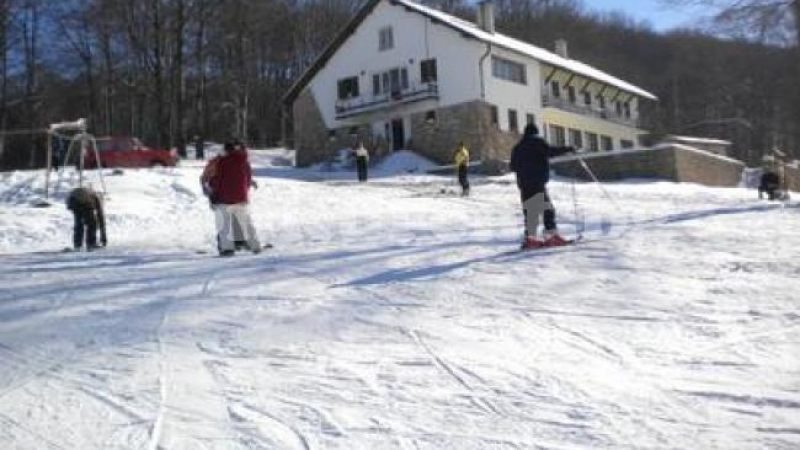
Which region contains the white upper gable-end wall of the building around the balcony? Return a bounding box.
[311,2,482,130]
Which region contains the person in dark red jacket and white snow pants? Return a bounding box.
[208,141,261,256]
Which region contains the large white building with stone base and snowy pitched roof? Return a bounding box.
[284,0,656,165]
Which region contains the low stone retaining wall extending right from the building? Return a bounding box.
[553,145,745,186]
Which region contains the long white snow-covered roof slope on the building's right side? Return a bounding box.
[392,0,658,100]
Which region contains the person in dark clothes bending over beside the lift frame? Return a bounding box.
[67,186,108,251]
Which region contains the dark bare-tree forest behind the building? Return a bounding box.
[0,0,800,167]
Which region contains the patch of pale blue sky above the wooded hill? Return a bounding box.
[584,0,707,31]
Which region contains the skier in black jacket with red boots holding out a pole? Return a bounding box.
[510,123,575,249]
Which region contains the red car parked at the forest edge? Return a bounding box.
[84,137,178,167]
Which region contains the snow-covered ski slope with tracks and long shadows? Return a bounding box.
[0,153,800,450]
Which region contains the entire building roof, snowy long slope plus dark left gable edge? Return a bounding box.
[283,0,658,105]
